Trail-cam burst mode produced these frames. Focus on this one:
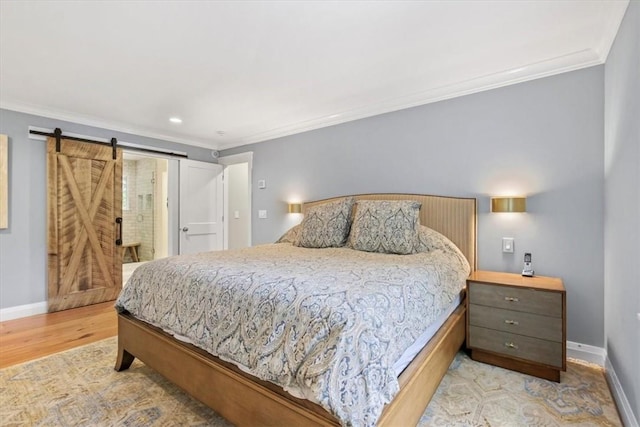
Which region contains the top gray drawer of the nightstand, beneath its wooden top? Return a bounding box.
[469,282,562,318]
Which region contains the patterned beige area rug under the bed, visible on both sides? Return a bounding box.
[0,338,622,427]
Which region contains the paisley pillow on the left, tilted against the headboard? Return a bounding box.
[294,197,353,248]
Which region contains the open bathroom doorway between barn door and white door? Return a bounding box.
[122,151,170,284]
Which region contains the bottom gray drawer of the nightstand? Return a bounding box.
[469,326,563,368]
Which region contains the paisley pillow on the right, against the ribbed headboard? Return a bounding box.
[348,200,421,254]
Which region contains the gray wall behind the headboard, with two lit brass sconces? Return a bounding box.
[222,66,604,347]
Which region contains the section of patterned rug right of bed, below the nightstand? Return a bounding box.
[418,352,622,427]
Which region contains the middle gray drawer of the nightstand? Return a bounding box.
[469,304,563,342]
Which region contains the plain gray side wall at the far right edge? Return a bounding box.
[604,1,640,420]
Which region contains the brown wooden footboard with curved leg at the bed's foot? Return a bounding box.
[115,314,339,426]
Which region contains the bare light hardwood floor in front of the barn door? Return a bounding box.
[0,301,118,369]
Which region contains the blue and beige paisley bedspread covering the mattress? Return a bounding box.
[116,243,469,426]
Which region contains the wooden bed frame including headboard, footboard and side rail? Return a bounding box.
[115,194,476,426]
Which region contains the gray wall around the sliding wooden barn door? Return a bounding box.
[0,109,213,308]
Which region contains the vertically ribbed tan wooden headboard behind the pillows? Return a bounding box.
[302,193,478,270]
